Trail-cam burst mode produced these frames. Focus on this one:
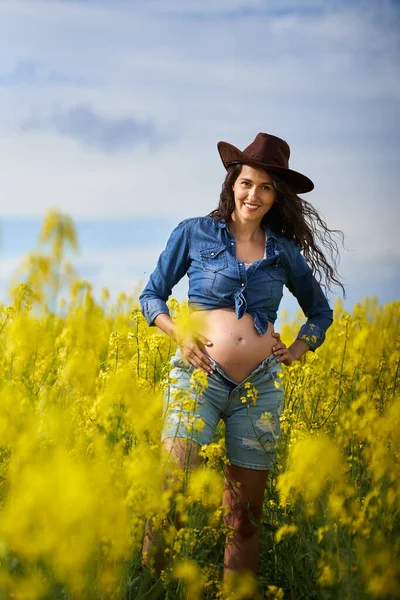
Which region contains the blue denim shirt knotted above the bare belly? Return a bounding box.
[139,217,333,350]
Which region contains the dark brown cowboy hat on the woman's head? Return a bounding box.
[217,133,314,194]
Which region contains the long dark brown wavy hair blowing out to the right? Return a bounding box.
[209,164,346,297]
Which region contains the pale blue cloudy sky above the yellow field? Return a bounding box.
[0,0,400,318]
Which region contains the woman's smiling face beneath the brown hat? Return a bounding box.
[232,165,277,223]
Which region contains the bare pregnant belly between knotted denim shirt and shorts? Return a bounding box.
[191,308,276,383]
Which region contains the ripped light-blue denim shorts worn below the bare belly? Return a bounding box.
[161,349,284,470]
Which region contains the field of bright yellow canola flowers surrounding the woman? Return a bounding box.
[0,213,400,600]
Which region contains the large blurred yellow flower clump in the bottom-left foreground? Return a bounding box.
[0,428,130,594]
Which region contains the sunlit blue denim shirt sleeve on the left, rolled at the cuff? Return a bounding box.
[139,220,190,326]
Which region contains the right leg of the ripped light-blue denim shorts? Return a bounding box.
[225,371,284,470]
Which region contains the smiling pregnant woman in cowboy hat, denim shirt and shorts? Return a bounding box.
[140,133,341,577]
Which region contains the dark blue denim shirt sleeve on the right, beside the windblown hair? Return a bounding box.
[288,248,333,351]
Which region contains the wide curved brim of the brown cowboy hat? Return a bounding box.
[217,142,314,194]
